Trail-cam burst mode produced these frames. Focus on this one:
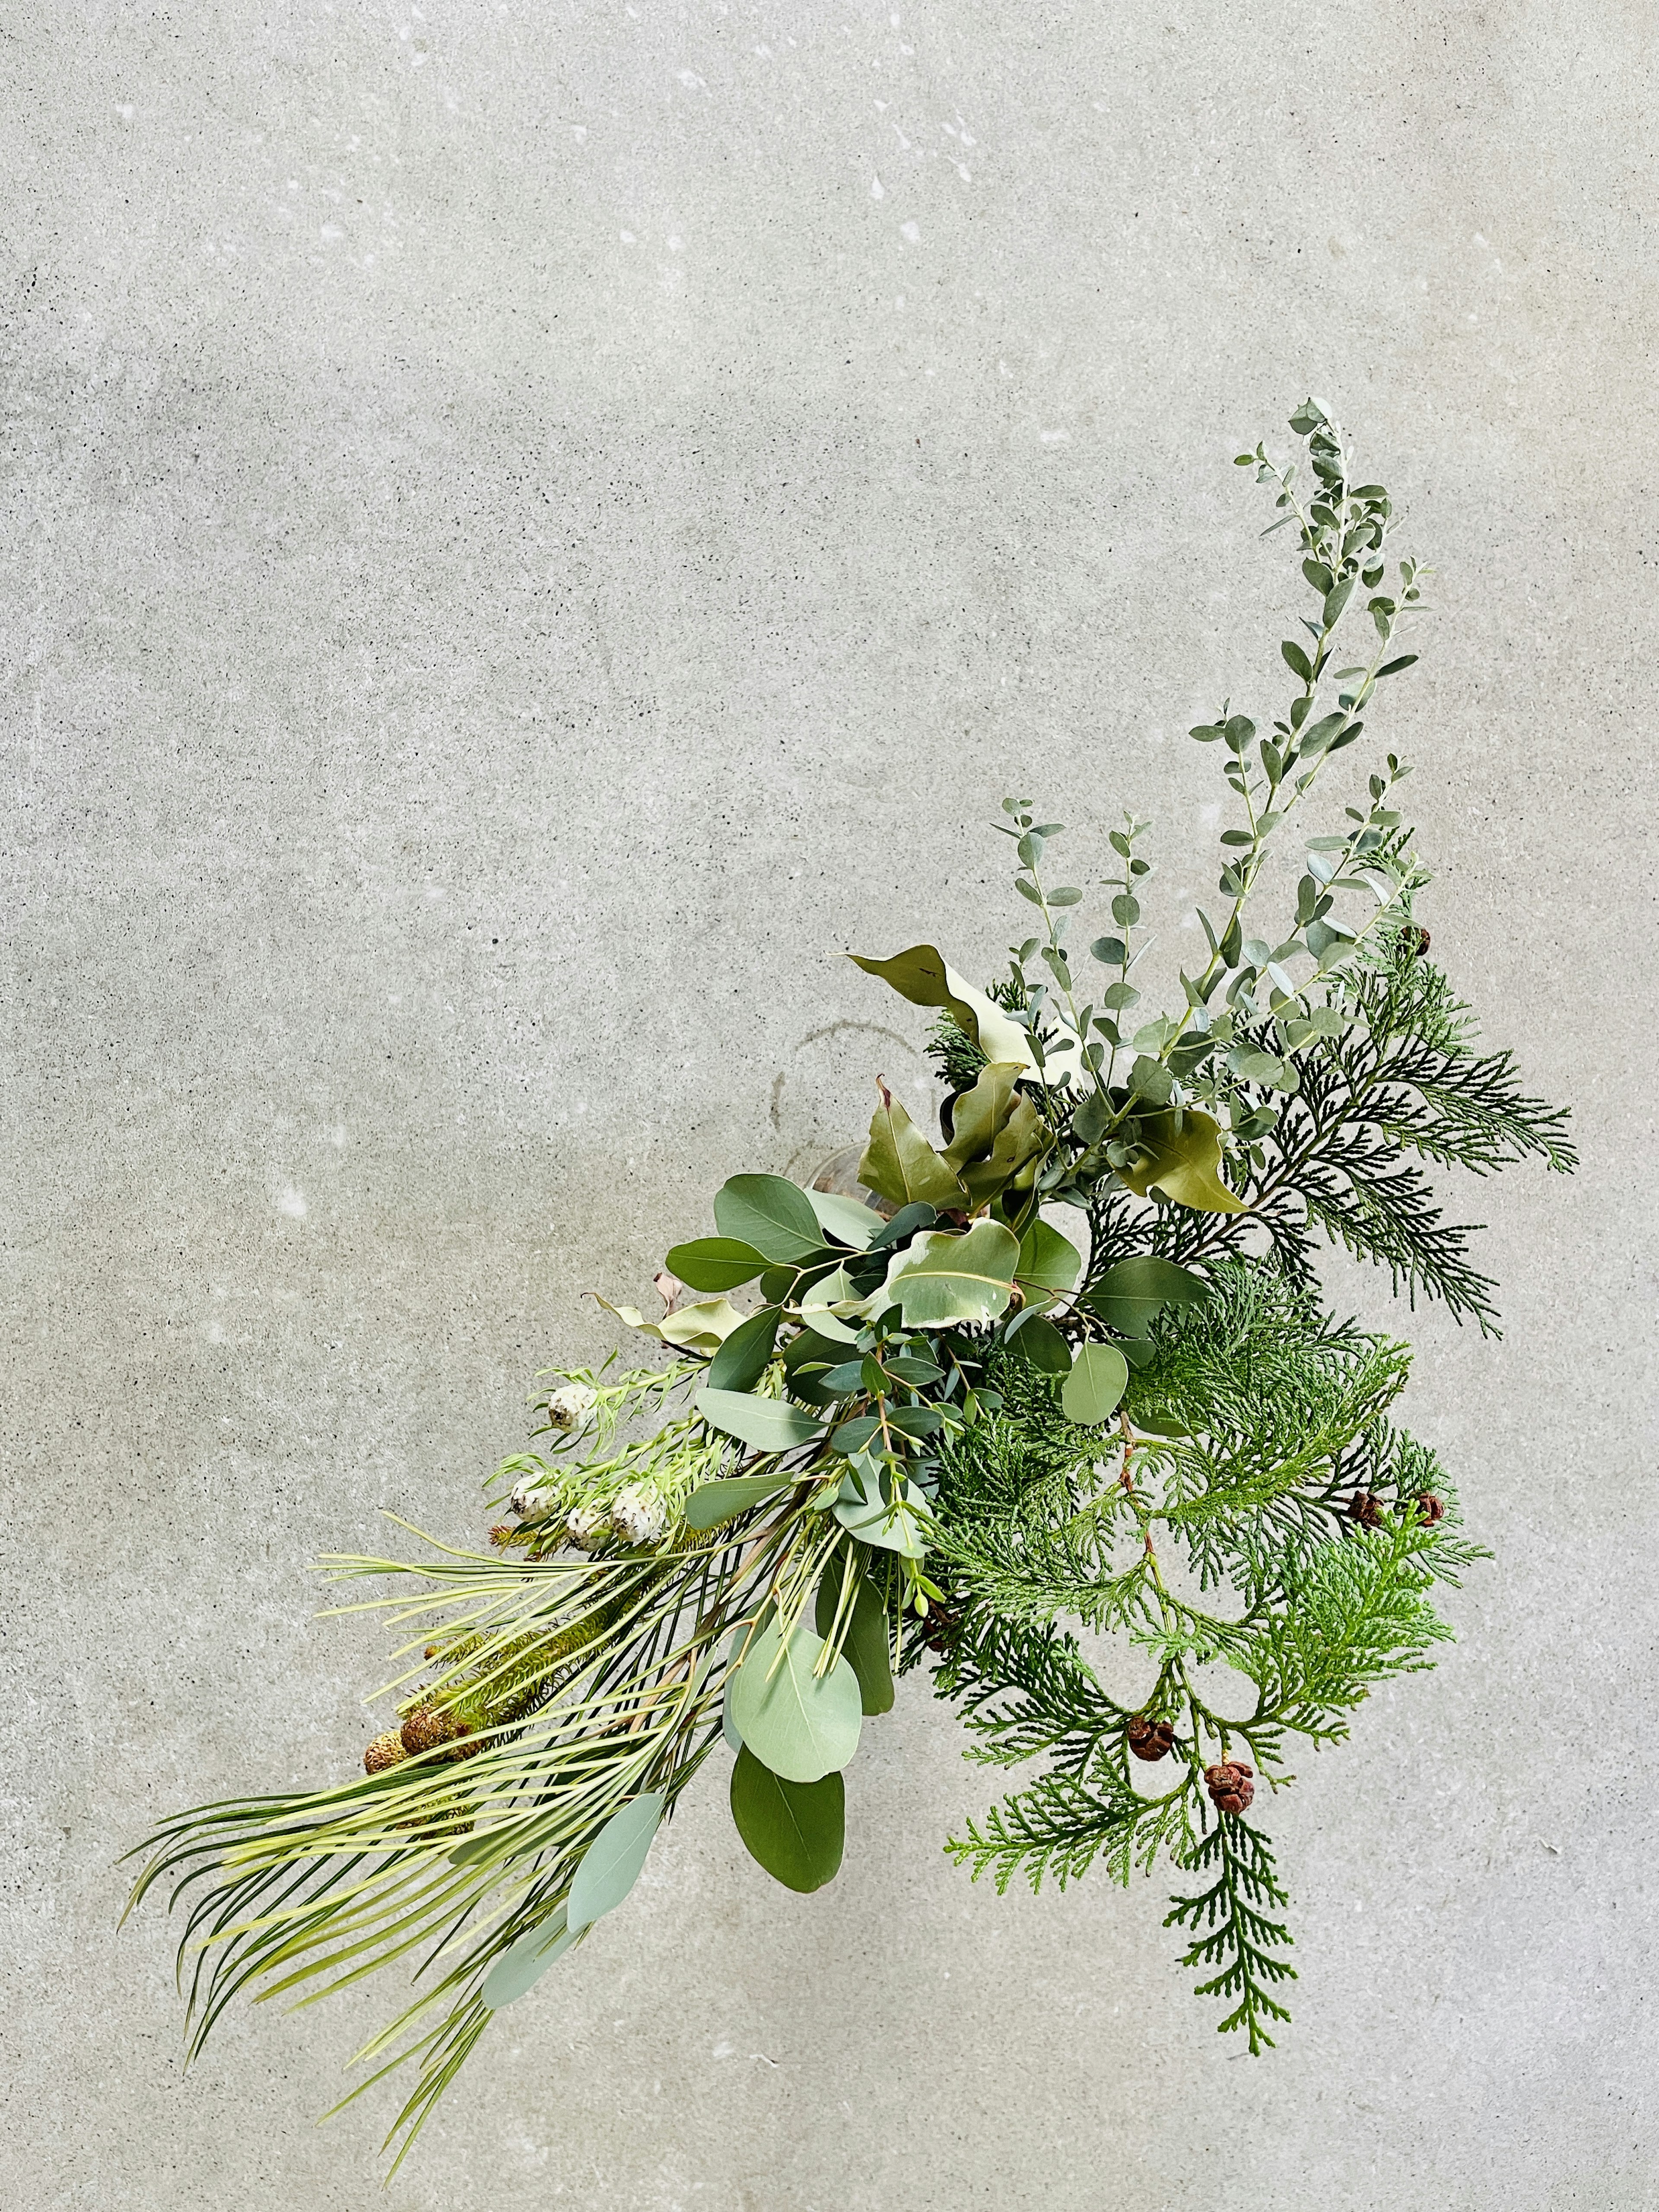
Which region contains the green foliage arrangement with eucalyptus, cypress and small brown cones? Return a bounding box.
[135,400,1573,2170]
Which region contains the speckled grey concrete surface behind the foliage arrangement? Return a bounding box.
[0,0,1659,2212]
